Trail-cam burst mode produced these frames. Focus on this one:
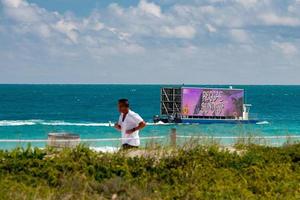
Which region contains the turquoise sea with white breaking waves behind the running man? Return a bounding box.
[0,85,300,148]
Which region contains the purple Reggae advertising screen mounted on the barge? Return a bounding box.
[181,88,244,117]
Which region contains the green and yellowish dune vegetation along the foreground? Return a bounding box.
[0,144,300,200]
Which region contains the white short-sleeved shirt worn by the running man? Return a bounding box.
[118,110,144,146]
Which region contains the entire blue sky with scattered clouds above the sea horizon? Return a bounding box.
[0,0,300,84]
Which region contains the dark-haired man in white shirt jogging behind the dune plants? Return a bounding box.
[115,99,146,149]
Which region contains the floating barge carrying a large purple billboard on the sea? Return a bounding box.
[153,87,258,124]
